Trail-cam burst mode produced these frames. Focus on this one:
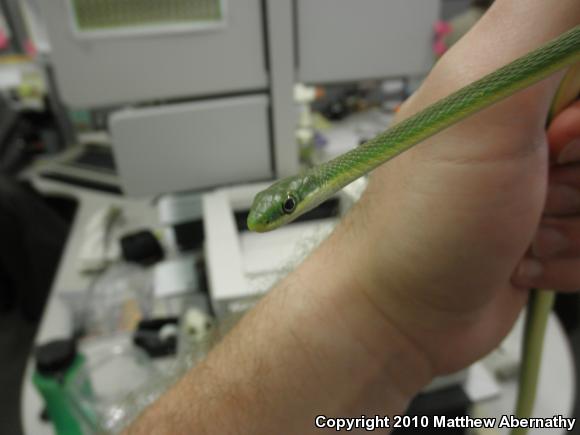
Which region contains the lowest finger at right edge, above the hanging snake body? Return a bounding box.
[512,257,580,292]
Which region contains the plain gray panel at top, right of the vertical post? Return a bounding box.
[296,0,440,83]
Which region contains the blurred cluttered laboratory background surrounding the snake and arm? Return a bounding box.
[0,0,580,435]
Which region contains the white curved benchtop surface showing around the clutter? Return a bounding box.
[21,177,576,435]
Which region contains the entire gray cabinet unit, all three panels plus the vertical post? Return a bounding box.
[38,0,439,195]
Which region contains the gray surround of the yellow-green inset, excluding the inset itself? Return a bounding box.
[39,0,267,108]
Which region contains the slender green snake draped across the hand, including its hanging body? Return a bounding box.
[247,25,580,433]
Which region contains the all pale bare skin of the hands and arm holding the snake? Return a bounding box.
[127,0,580,435]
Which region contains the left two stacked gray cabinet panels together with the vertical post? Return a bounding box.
[35,0,298,195]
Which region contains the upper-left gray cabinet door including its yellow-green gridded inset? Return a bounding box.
[39,0,267,108]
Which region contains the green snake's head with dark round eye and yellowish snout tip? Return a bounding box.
[247,175,318,233]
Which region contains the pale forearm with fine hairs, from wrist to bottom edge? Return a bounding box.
[128,237,430,434]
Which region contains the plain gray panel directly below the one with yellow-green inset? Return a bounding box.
[110,95,272,195]
